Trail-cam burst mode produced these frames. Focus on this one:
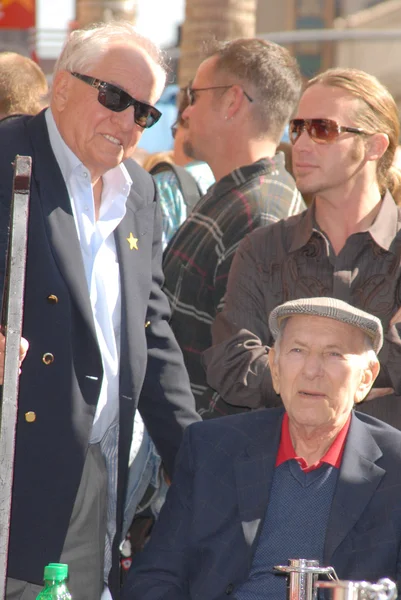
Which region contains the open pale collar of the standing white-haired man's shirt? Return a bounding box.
[45,108,132,199]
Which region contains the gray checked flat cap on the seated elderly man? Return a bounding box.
[269,297,383,354]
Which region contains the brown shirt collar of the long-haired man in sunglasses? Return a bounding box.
[290,191,399,252]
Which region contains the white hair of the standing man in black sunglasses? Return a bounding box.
[54,21,167,76]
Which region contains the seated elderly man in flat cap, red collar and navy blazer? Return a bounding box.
[124,298,401,600]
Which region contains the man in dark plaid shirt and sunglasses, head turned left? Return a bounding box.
[163,39,305,418]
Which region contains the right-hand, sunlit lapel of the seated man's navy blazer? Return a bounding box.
[324,414,385,565]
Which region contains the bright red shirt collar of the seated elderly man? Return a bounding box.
[276,413,351,473]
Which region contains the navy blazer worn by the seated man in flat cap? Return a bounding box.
[123,408,401,600]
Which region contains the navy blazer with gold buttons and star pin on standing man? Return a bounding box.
[0,112,198,589]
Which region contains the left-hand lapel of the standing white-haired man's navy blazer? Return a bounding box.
[27,112,96,340]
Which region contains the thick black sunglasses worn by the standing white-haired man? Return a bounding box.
[71,72,162,129]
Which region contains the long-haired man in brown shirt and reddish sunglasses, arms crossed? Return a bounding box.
[204,69,401,428]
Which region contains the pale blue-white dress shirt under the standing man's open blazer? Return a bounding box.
[46,108,132,443]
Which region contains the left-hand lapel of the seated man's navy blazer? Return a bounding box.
[235,411,282,556]
